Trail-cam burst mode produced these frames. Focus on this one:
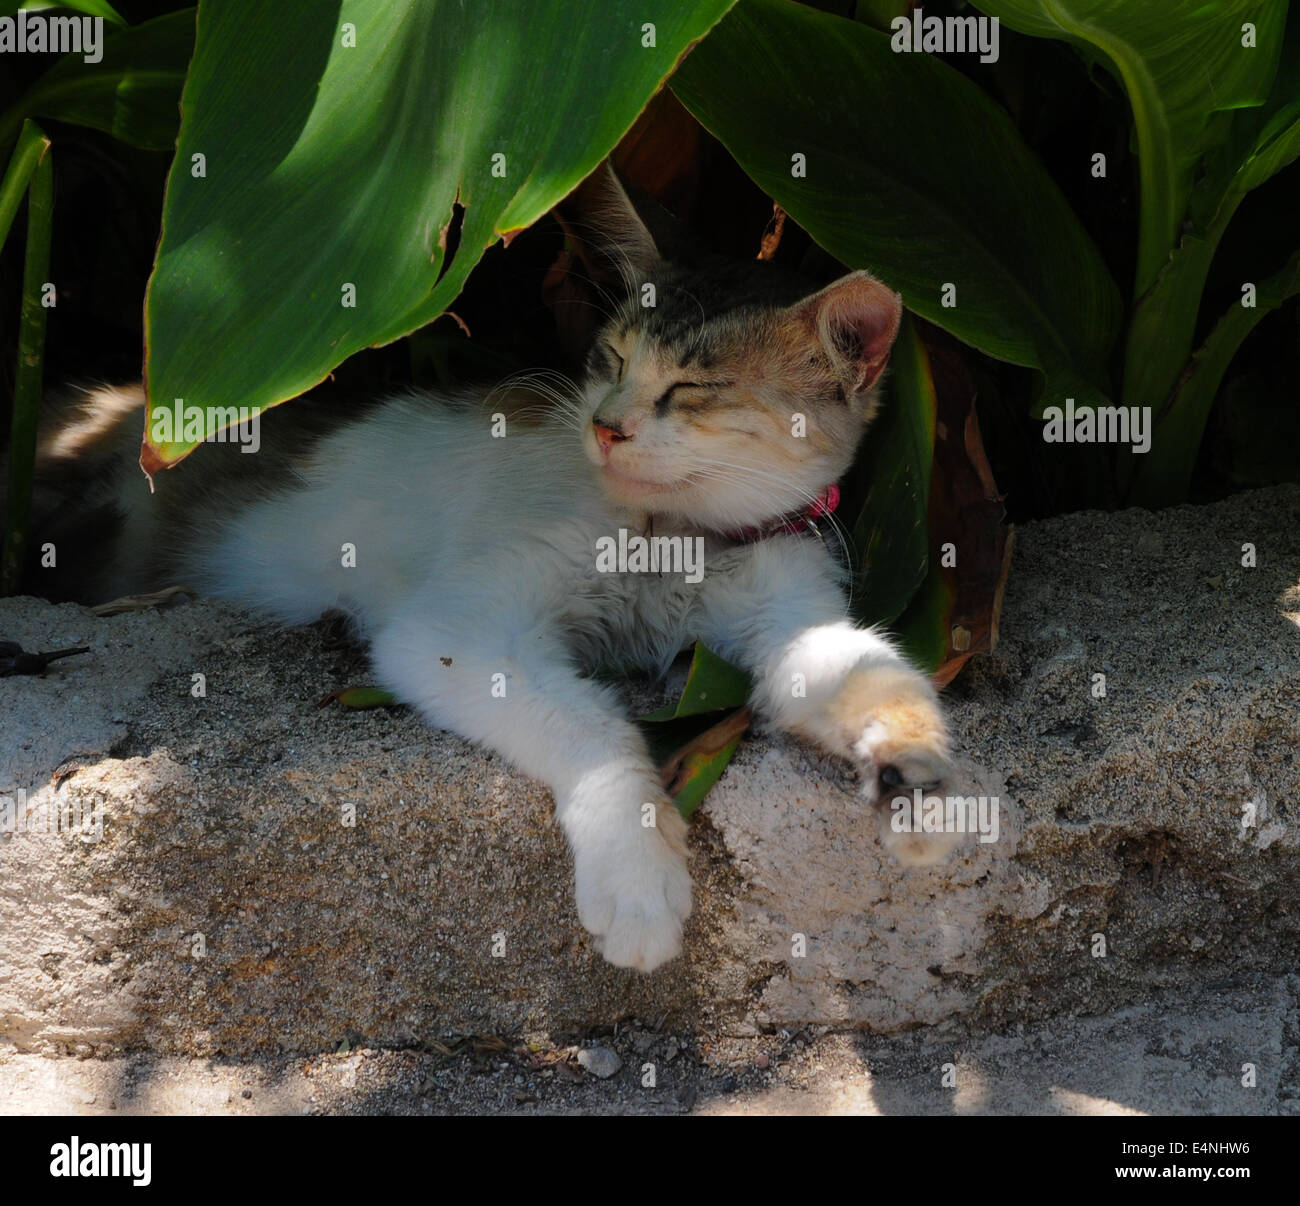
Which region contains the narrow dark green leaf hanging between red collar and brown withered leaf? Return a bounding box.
[848,314,937,624]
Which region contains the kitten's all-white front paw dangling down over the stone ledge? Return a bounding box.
[575,801,690,972]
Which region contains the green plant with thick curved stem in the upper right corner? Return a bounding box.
[980,0,1300,506]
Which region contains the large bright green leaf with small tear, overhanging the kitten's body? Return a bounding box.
[142,0,732,469]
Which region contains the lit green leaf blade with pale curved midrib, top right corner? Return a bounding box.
[978,0,1287,296]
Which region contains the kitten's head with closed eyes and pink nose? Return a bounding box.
[580,163,902,532]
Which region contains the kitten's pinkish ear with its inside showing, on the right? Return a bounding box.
[790,272,902,396]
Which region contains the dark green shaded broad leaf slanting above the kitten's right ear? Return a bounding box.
[672,0,1121,403]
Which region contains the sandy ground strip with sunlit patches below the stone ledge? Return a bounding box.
[0,976,1300,1115]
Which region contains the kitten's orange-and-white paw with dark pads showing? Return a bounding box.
[832,667,959,867]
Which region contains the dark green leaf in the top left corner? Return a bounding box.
[0,8,194,151]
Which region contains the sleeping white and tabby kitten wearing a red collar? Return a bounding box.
[22,165,950,971]
